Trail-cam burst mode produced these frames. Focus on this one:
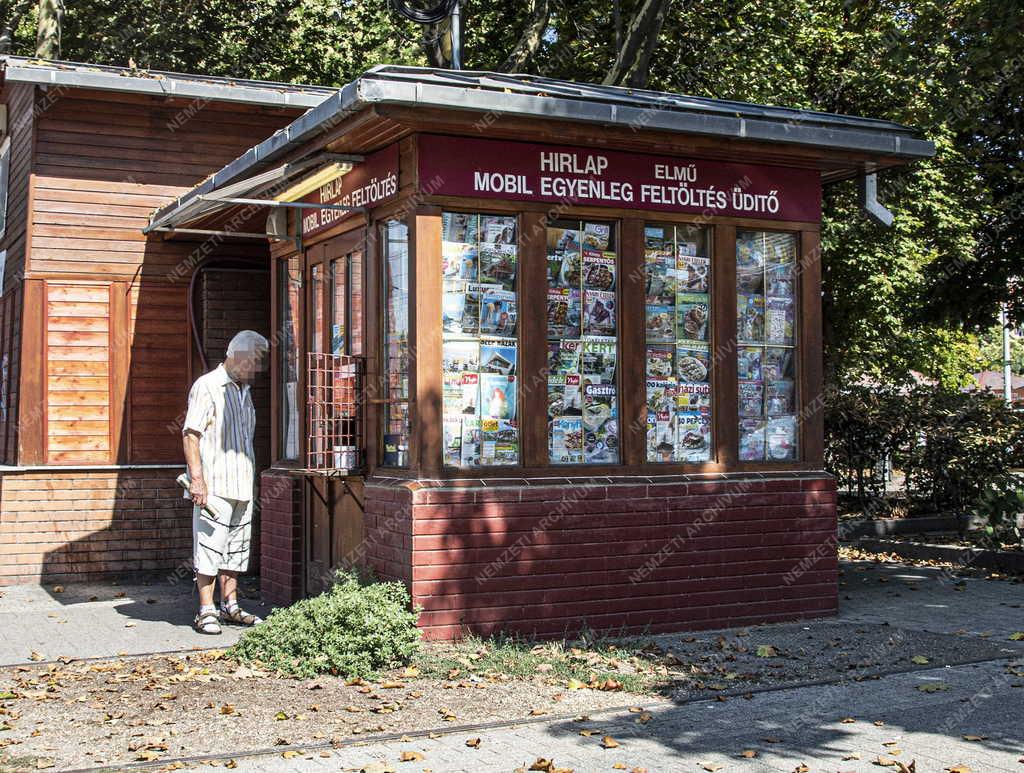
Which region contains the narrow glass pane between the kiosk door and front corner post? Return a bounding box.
[383,220,410,467]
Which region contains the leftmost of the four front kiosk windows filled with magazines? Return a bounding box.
[441,212,519,467]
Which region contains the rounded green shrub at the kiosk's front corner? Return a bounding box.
[227,572,420,678]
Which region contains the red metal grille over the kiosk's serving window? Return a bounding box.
[306,352,362,474]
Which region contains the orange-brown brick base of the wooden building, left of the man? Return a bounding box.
[0,468,191,585]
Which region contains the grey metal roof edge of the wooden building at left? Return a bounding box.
[2,56,335,109]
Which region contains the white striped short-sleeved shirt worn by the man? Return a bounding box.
[181,363,256,502]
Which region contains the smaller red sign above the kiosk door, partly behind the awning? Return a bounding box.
[302,144,398,237]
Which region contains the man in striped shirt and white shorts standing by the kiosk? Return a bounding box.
[181,330,268,634]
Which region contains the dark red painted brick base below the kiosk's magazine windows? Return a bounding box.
[367,474,838,639]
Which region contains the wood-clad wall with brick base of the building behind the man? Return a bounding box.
[0,84,301,584]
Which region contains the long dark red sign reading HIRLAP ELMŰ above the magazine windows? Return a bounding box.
[418,134,821,221]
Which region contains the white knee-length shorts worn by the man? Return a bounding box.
[193,497,253,576]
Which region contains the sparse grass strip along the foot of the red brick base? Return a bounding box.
[414,633,665,693]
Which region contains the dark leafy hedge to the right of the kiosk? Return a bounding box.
[825,384,1024,513]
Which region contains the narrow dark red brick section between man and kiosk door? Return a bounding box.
[260,472,303,605]
